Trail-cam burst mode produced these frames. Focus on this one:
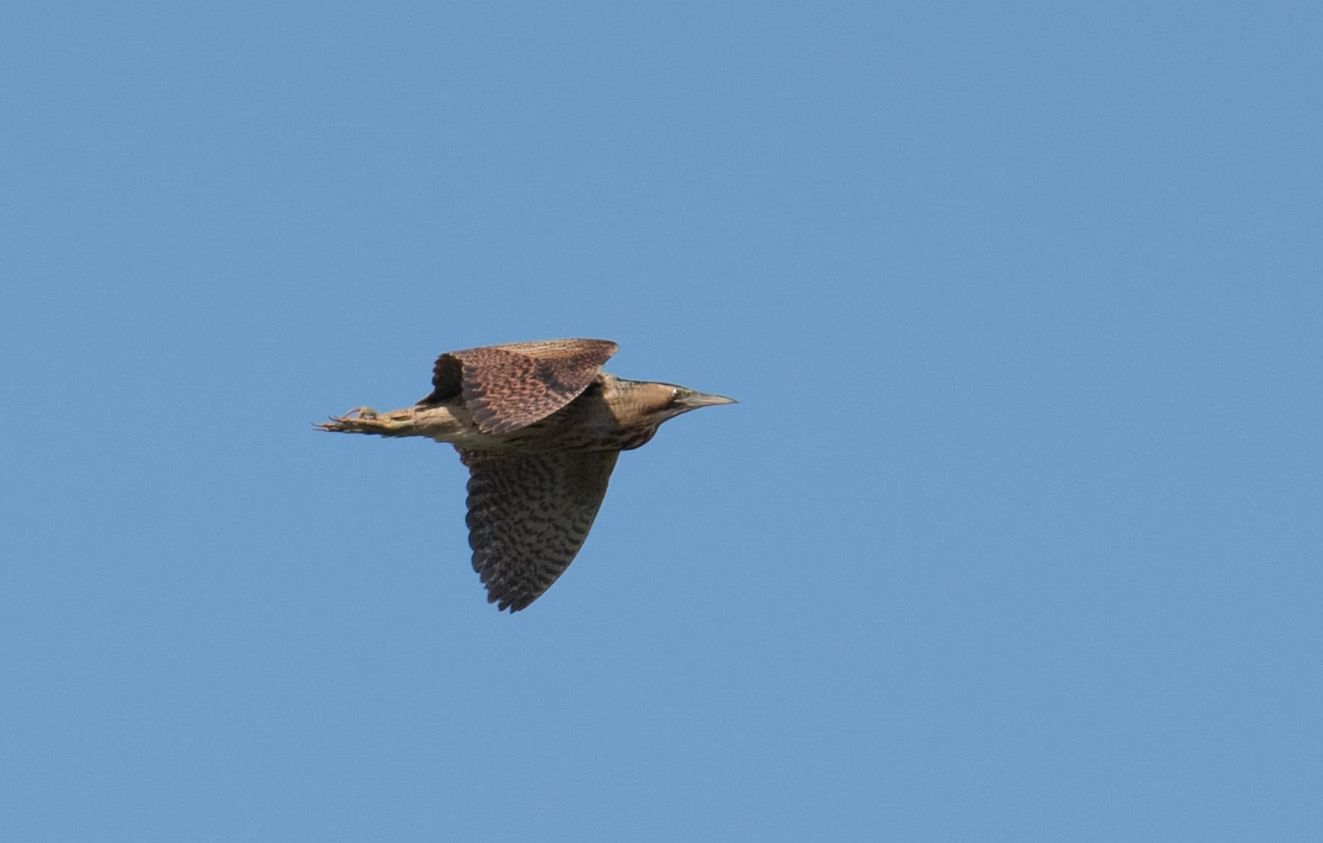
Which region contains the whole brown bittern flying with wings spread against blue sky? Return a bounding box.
[318,339,734,611]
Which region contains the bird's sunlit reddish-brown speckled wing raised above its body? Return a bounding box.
[419,340,618,433]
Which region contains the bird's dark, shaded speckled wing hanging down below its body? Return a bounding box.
[459,450,619,611]
